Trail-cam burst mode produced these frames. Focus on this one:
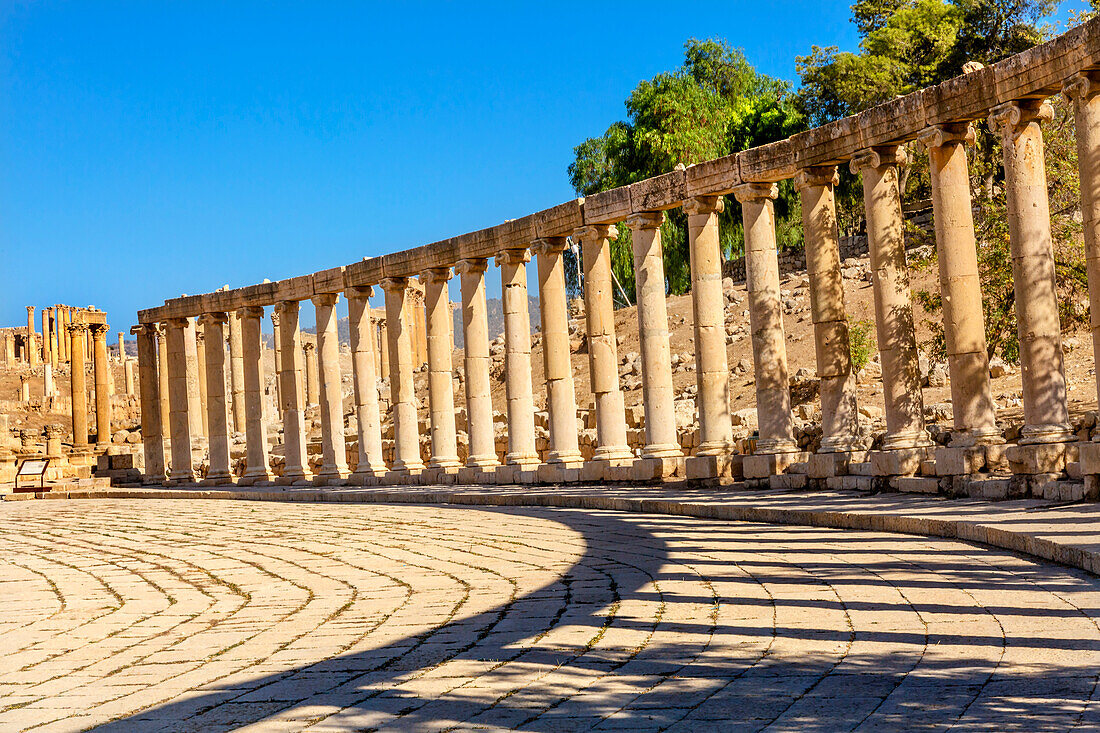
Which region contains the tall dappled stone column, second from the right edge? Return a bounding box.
[989,99,1074,444]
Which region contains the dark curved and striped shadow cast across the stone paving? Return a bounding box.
[95,507,1100,733]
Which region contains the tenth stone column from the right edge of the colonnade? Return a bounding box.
[531,237,583,471]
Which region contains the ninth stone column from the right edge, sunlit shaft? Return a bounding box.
[573,225,634,468]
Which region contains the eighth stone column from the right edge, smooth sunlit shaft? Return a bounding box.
[629,211,683,479]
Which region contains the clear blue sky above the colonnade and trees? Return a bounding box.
[0,0,1082,329]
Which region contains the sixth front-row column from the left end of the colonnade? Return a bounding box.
[314,293,348,483]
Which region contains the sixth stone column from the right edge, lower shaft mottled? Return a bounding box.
[734,183,798,453]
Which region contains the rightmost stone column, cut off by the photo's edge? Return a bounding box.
[1063,72,1100,420]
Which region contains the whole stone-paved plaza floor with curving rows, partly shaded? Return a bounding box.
[0,500,1100,732]
